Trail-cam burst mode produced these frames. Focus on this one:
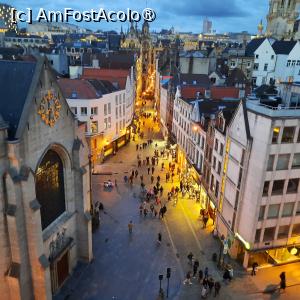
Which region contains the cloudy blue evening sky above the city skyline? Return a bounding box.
[9,0,269,33]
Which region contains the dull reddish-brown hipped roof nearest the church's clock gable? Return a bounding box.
[58,78,99,99]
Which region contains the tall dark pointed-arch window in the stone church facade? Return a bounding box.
[35,150,66,229]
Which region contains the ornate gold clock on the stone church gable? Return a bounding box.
[38,90,61,127]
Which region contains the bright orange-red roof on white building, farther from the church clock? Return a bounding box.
[82,68,129,89]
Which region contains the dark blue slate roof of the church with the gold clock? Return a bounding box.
[0,61,36,139]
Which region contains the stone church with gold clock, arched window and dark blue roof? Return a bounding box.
[0,58,92,300]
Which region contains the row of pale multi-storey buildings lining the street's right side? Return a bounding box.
[161,79,300,267]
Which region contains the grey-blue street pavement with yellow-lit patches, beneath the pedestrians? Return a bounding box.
[55,109,299,300]
